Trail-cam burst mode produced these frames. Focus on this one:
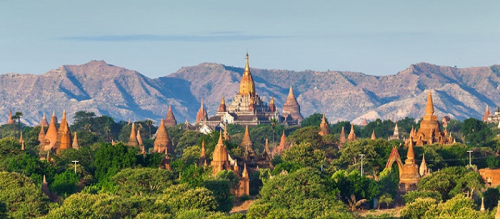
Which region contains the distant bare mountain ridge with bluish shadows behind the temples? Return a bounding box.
[0,61,500,124]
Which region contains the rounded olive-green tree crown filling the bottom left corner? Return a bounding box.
[0,172,49,218]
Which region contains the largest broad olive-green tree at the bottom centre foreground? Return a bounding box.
[247,168,352,218]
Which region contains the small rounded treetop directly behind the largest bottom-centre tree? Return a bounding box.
[282,143,325,168]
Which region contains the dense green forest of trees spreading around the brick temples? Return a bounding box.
[0,111,500,218]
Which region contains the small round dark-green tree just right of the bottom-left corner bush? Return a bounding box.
[50,170,80,196]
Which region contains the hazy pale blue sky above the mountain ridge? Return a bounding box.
[0,0,500,77]
